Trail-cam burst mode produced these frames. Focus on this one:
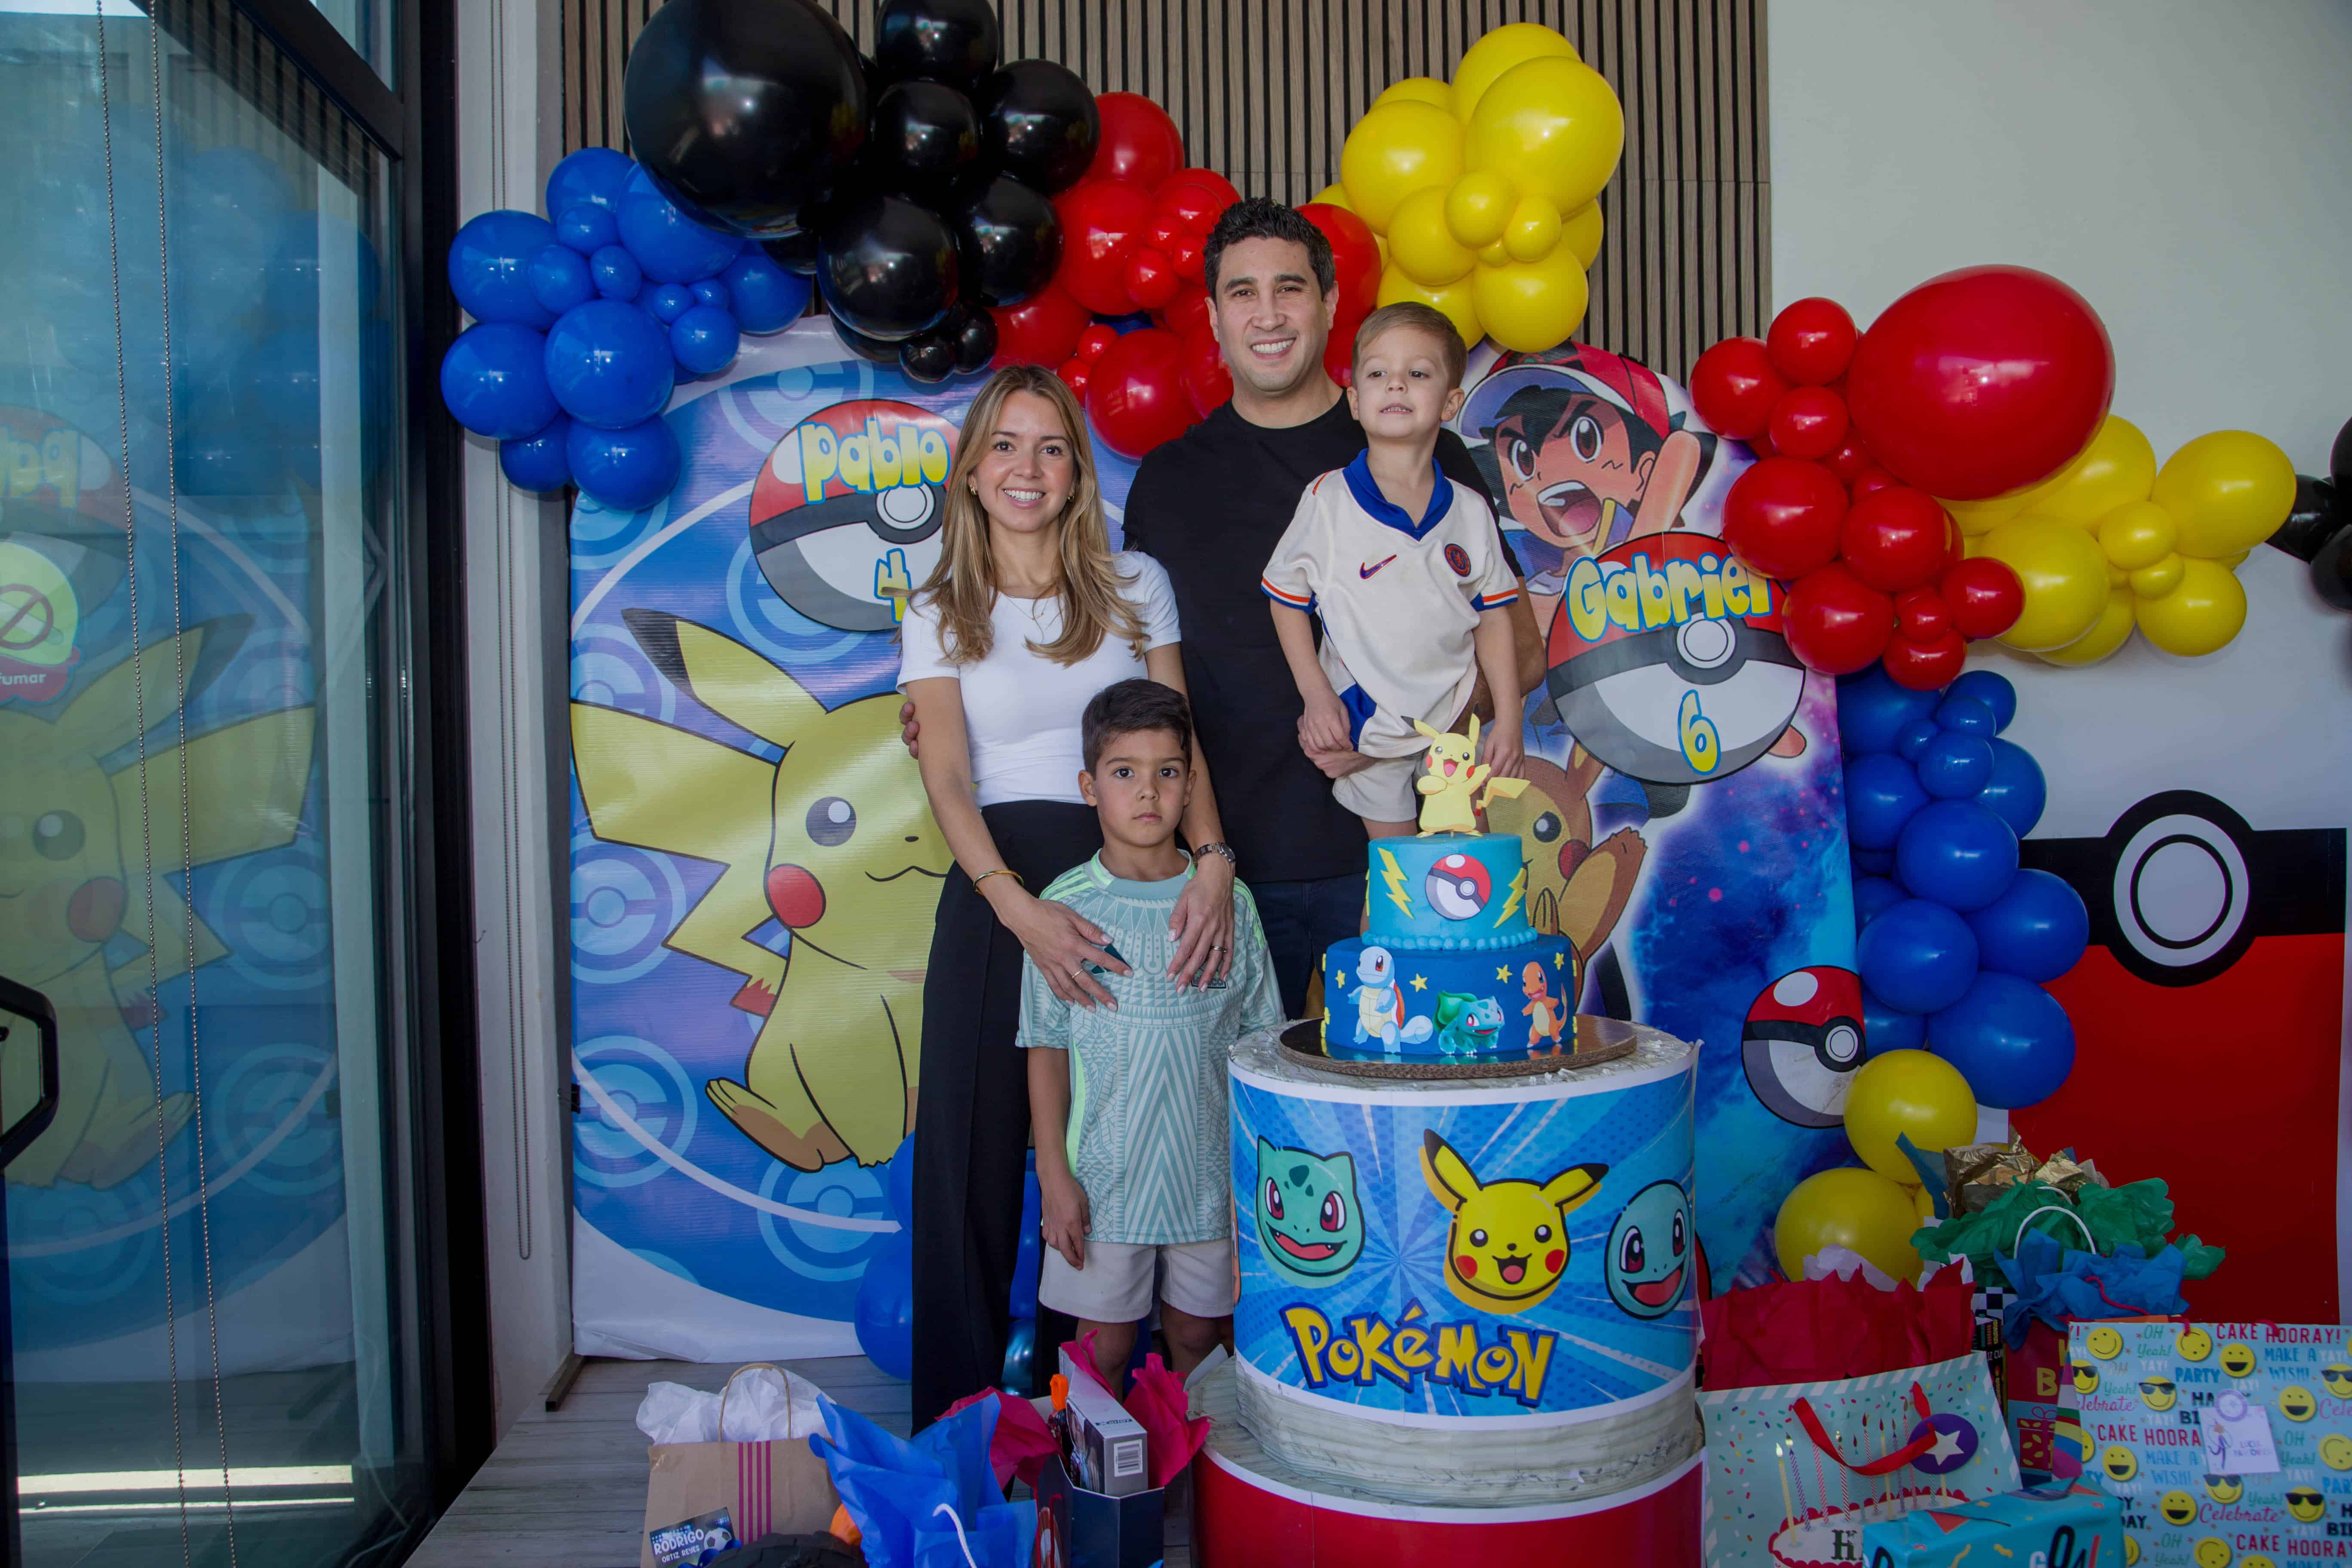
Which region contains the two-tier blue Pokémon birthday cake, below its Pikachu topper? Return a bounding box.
[1322,832,1578,1063]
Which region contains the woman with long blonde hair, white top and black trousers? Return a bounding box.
[898,364,1235,1429]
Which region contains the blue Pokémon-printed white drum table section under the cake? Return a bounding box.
[1232,1018,1698,1502]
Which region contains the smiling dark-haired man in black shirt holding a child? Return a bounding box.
[1124,200,1543,1018]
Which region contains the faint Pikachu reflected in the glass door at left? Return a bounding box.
[0,616,315,1187]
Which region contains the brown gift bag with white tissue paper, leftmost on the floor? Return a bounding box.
[637,1361,840,1568]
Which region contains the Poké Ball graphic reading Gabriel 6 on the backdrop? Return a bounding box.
[1548,534,1804,785]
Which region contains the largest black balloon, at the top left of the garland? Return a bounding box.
[623,0,868,237]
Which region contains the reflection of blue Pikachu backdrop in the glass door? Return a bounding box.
[0,399,348,1382]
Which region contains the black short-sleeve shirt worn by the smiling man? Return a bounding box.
[1124,397,1519,882]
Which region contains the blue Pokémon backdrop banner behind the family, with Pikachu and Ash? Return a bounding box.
[572,320,1860,1361]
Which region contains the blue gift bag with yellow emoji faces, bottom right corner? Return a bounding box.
[2067,1319,2352,1568]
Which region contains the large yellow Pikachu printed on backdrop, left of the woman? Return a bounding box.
[572,609,950,1171]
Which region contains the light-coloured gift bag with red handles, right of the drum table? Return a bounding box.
[1698,1354,2018,1568]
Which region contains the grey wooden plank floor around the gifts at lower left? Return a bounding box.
[409,1357,1192,1568]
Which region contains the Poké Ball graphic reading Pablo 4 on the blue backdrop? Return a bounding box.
[750,397,955,632]
